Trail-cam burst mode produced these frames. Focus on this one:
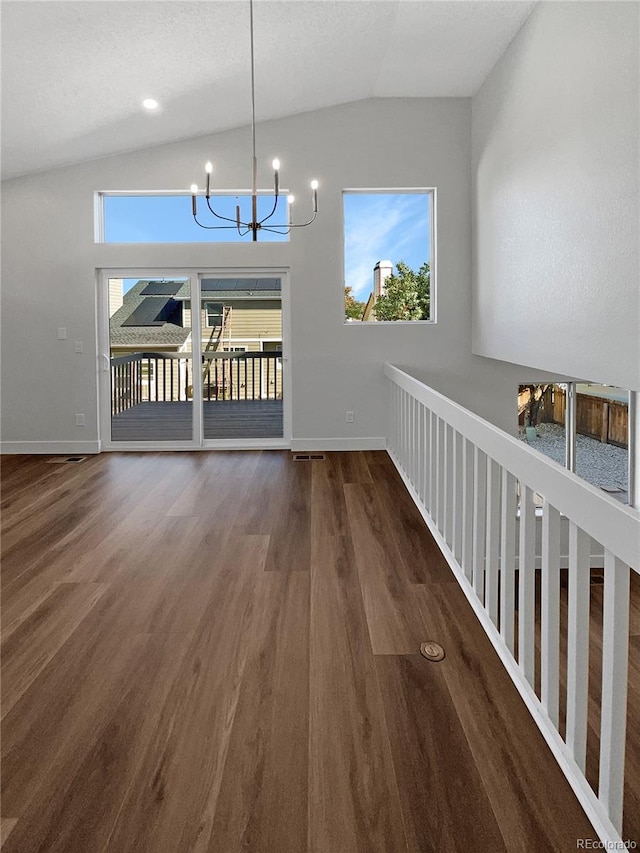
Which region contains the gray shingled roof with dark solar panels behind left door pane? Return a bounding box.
[109,280,191,348]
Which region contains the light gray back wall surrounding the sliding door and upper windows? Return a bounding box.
[2,99,552,450]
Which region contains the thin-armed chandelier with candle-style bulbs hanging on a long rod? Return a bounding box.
[191,0,318,242]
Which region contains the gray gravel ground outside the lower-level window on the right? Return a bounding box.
[518,424,627,491]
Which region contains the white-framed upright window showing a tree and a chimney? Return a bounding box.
[342,188,436,325]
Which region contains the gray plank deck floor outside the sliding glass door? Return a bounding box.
[111,400,283,441]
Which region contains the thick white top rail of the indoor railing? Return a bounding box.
[384,363,640,572]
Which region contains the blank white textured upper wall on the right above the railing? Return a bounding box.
[472,2,640,389]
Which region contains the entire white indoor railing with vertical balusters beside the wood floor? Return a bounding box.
[385,364,640,849]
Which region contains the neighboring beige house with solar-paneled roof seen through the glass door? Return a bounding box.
[109,278,282,400]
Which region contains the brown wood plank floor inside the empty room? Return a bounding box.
[1,451,616,853]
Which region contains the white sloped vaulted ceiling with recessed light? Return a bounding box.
[0,0,536,177]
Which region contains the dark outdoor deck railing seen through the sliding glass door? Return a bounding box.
[111,352,282,415]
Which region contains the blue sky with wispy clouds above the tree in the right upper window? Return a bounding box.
[344,193,431,302]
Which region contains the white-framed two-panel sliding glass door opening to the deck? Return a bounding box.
[101,271,287,449]
